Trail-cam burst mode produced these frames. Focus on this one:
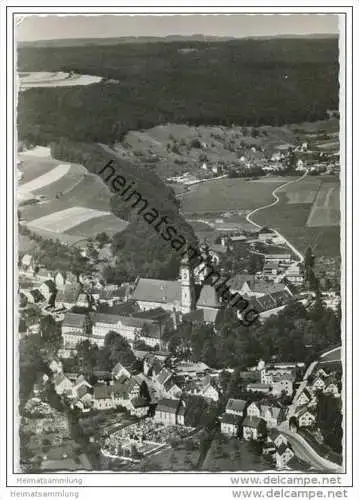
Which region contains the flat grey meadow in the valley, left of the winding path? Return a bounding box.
[181,177,287,214]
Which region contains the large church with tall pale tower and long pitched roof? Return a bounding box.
[133,250,221,323]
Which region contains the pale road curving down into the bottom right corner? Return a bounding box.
[278,422,343,474]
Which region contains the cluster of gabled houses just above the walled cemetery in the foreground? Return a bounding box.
[50,353,219,425]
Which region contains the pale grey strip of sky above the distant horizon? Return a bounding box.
[16,14,339,42]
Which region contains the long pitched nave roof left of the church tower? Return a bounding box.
[133,278,181,303]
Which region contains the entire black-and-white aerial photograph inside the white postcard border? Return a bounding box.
[14,14,345,474]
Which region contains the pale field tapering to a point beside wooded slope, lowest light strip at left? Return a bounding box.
[28,207,115,233]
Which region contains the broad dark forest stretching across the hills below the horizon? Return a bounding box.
[18,38,338,144]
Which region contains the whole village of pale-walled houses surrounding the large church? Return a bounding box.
[19,220,341,470]
